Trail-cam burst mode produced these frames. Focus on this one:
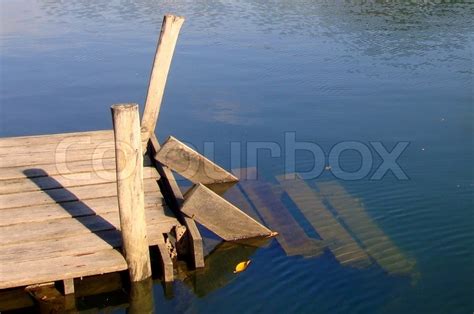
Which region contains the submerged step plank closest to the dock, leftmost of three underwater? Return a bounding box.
[239,169,324,257]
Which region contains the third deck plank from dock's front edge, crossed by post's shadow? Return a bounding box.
[0,209,178,245]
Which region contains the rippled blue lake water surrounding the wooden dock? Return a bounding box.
[0,0,474,313]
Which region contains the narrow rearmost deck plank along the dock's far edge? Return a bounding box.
[0,130,113,148]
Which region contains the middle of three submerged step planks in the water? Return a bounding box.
[277,175,371,267]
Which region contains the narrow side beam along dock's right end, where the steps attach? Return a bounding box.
[149,134,204,268]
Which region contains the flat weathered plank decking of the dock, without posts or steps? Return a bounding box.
[0,130,180,289]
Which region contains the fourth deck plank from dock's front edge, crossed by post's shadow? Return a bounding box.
[0,192,168,226]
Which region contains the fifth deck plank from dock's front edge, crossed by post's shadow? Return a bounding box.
[0,179,159,210]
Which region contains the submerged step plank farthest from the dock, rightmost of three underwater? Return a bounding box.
[317,182,415,274]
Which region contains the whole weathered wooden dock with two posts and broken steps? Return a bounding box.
[0,15,274,295]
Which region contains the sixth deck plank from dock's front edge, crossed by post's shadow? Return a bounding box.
[0,167,160,194]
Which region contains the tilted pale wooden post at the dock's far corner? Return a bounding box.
[141,15,184,153]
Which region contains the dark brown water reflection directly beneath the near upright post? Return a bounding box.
[127,278,155,314]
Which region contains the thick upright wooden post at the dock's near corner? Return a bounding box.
[112,104,151,282]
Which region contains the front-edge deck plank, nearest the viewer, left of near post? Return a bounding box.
[0,250,127,289]
